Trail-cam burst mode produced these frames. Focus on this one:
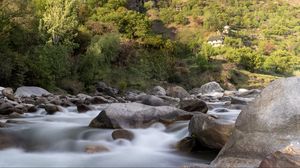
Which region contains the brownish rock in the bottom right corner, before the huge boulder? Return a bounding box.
[259,145,300,168]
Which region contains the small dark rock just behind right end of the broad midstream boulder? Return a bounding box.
[180,99,208,113]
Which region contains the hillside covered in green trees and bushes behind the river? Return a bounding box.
[0,0,300,93]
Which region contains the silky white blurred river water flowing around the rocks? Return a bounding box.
[0,105,240,167]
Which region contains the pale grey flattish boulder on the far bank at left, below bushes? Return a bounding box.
[15,86,51,97]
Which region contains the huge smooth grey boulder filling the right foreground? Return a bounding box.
[212,77,300,168]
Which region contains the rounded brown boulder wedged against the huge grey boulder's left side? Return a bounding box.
[189,113,234,149]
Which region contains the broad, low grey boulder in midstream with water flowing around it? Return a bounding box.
[89,103,192,128]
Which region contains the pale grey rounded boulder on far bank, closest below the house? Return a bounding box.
[191,82,224,94]
